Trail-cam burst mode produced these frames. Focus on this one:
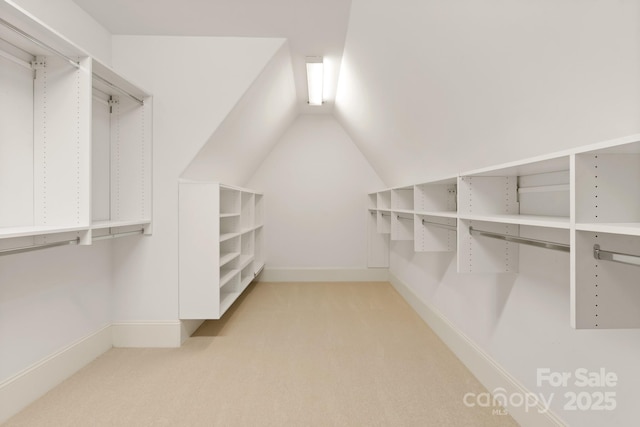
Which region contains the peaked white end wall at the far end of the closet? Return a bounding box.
[247,115,382,269]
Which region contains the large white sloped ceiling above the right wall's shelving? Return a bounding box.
[335,0,640,186]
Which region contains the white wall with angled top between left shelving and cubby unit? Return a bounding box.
[113,36,284,323]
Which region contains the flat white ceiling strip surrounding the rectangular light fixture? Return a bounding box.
[74,0,351,112]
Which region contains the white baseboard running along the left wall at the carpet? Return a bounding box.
[0,326,112,424]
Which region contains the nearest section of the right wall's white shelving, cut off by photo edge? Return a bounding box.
[571,138,640,329]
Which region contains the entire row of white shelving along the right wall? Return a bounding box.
[369,135,640,329]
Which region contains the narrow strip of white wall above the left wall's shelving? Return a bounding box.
[7,0,111,65]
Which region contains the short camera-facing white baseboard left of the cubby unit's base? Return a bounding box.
[111,320,183,348]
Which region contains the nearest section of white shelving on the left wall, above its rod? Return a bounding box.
[0,4,91,247]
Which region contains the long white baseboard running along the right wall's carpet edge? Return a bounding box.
[389,272,565,427]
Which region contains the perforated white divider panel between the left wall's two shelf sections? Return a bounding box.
[34,57,91,226]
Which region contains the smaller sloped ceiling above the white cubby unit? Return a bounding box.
[181,43,298,186]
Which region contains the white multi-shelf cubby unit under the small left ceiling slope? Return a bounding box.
[179,180,265,319]
